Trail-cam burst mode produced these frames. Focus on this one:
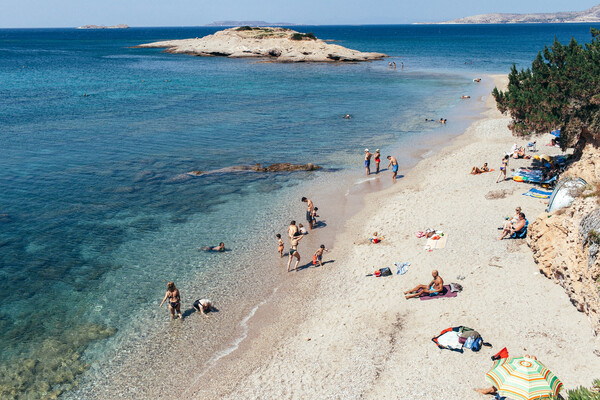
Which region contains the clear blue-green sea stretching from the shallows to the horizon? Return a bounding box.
[0,24,600,399]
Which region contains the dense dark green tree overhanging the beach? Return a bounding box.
[492,28,600,154]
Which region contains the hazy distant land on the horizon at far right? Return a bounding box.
[437,4,600,24]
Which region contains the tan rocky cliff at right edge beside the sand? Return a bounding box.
[528,145,600,335]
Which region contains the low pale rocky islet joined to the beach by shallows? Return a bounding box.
[135,26,387,62]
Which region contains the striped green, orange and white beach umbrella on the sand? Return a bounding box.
[485,357,562,400]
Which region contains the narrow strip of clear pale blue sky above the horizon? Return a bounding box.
[0,0,599,28]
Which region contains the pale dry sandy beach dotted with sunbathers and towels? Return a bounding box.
[182,76,600,399]
